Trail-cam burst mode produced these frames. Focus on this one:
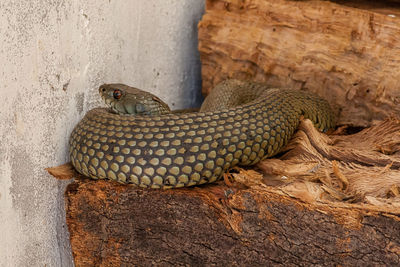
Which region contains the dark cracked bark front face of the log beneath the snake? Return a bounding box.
[66,177,400,266]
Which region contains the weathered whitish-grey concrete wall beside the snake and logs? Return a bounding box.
[0,0,204,266]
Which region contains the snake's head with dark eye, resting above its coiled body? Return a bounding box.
[99,83,170,115]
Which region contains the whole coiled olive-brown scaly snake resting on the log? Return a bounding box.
[69,79,335,189]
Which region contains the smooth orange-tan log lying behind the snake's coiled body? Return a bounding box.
[199,0,400,126]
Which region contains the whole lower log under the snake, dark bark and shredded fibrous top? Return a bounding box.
[49,119,400,266]
